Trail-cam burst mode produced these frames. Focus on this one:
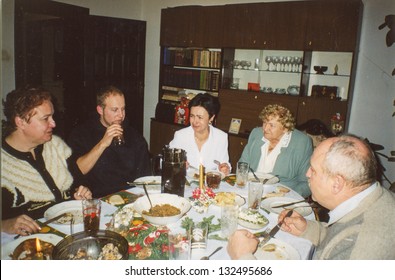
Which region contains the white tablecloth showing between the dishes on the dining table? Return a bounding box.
[1,175,315,260]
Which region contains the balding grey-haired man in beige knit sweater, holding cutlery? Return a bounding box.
[228,135,395,260]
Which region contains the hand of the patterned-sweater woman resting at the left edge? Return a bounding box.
[1,215,41,236]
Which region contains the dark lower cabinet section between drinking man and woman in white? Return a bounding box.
[150,119,184,155]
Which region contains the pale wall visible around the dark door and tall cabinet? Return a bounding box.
[1,0,395,186]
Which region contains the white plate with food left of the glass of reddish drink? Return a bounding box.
[44,200,83,225]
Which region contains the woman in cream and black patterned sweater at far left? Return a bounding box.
[1,88,92,235]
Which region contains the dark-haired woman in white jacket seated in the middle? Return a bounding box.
[169,93,231,175]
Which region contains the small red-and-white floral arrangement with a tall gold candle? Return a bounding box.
[191,165,215,213]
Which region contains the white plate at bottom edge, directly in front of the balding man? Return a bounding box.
[254,238,300,260]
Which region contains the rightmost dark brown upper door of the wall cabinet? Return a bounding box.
[304,0,362,51]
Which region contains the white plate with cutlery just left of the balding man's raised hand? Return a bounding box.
[261,197,313,216]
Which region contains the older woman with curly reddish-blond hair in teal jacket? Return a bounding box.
[239,104,313,197]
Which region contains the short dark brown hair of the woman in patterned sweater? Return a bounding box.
[2,85,52,137]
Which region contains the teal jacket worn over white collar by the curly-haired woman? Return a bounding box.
[239,127,313,197]
